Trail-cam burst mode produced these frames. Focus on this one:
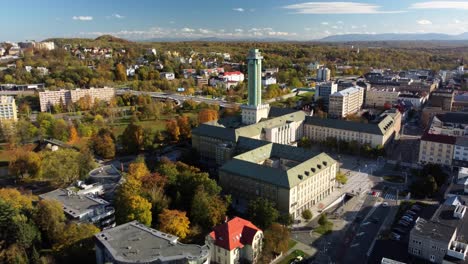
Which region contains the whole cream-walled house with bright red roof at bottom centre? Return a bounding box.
[205,217,263,264]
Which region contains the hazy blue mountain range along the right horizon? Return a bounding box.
[318,32,468,42]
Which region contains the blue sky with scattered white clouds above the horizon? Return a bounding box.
[0,0,468,41]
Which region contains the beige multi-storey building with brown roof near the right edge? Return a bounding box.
[419,131,456,166]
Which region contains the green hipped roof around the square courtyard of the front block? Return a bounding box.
[220,143,336,189]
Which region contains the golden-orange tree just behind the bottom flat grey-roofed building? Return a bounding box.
[159,209,190,239]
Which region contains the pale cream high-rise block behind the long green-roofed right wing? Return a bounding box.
[328,86,364,118]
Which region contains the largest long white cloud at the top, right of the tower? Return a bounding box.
[283,2,403,14]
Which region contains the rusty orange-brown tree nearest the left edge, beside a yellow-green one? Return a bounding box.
[8,150,41,179]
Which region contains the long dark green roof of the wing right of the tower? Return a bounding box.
[305,115,394,135]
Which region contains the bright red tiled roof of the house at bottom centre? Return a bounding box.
[210,217,261,251]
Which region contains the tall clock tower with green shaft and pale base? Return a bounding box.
[241,49,270,125]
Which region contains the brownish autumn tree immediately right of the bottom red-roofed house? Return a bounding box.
[265,223,290,255]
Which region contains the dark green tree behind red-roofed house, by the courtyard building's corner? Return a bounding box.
[247,198,279,229]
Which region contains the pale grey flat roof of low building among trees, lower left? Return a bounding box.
[39,189,109,218]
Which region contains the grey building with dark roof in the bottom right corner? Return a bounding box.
[408,204,468,263]
